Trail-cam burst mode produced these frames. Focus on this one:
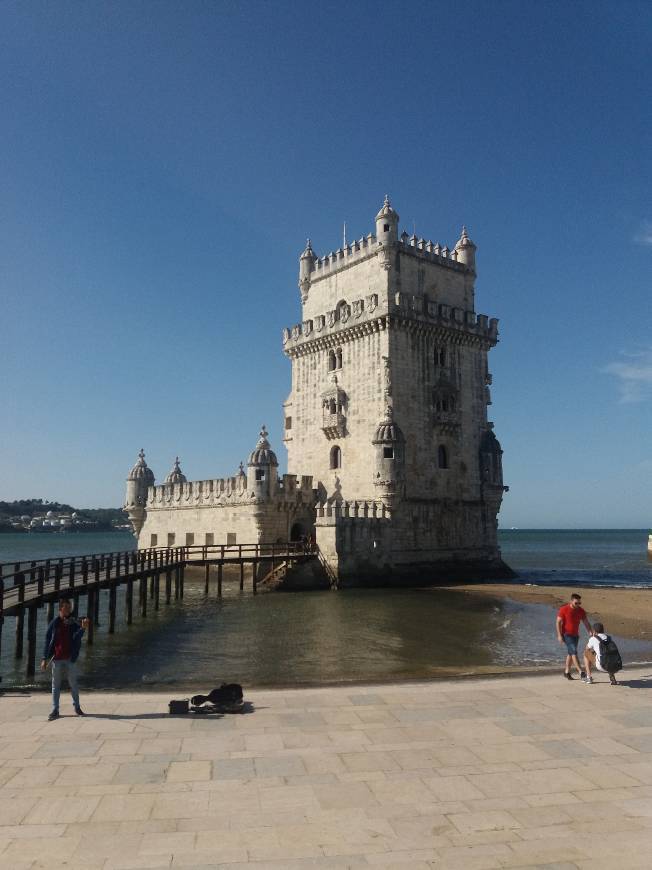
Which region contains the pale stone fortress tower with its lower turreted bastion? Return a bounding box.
[125,197,509,581]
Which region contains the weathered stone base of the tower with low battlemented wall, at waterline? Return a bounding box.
[315,500,515,586]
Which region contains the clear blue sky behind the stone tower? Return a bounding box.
[0,0,652,528]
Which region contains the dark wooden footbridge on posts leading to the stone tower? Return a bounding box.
[0,542,326,677]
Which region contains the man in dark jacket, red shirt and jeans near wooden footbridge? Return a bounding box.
[41,598,88,722]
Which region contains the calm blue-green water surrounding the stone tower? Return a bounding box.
[0,530,652,691]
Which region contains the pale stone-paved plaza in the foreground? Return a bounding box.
[0,668,652,870]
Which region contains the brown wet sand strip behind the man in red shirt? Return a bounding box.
[446,583,652,640]
